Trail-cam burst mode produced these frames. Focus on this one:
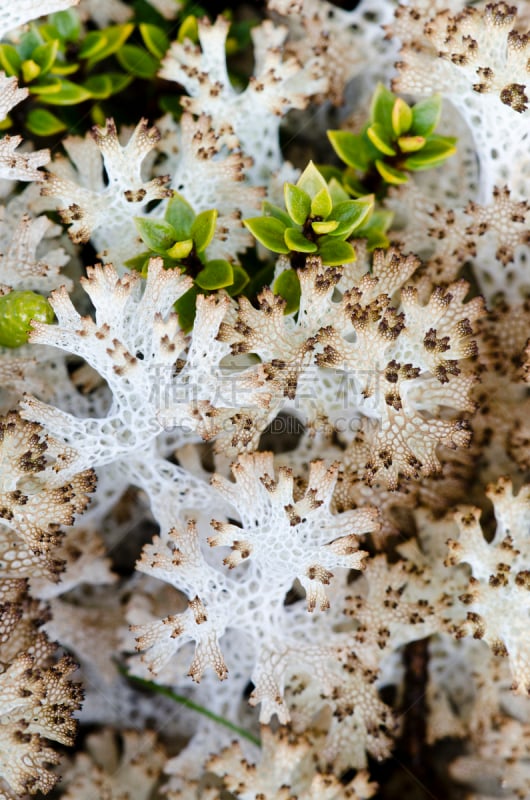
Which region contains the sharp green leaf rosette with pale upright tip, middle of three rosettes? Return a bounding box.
[244,161,374,266]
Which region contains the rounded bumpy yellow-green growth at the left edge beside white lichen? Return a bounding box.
[0,291,54,347]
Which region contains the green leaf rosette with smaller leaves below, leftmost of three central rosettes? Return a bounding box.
[125,192,249,329]
